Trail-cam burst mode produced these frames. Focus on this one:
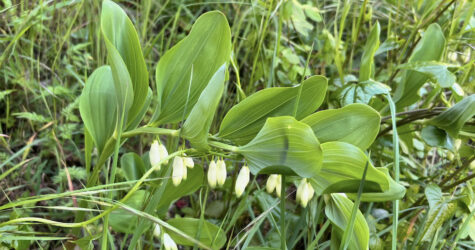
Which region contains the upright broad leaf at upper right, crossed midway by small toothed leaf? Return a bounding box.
[394,23,446,107]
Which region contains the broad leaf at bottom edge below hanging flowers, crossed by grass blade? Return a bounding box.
[164,218,226,249]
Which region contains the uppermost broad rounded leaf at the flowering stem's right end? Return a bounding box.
[302,103,381,150]
